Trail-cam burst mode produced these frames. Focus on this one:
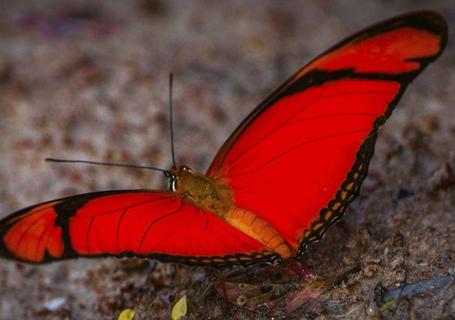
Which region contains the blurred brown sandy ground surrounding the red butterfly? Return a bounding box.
[0,0,455,319]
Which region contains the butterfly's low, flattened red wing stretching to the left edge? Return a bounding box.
[0,190,276,264]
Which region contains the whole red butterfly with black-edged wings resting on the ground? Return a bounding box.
[0,11,447,265]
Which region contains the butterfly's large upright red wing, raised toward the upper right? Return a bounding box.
[207,12,447,252]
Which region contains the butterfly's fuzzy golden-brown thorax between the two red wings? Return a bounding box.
[173,166,235,217]
